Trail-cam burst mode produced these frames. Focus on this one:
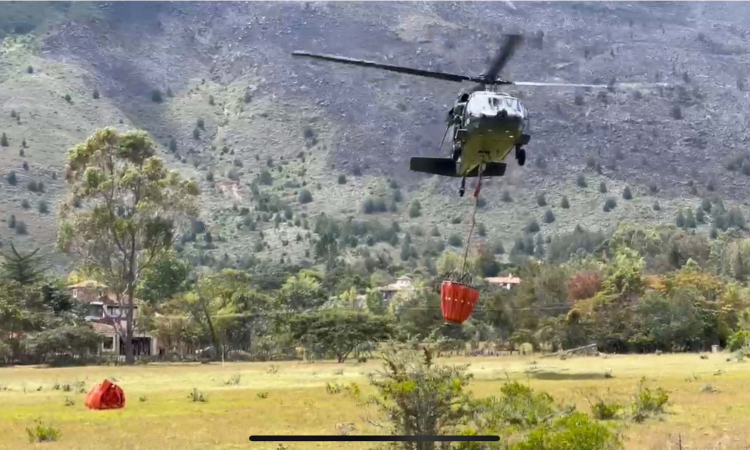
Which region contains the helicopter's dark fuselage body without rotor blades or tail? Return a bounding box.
[451,91,529,176]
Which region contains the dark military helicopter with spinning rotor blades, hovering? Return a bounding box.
[292,35,656,197]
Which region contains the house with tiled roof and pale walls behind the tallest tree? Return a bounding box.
[68,281,164,356]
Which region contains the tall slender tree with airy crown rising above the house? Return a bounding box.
[57,128,199,364]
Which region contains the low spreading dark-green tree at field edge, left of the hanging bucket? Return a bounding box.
[289,309,393,363]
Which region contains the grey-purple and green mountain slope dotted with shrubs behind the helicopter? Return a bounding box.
[0,2,750,270]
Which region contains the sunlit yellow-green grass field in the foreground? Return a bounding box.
[0,354,750,450]
